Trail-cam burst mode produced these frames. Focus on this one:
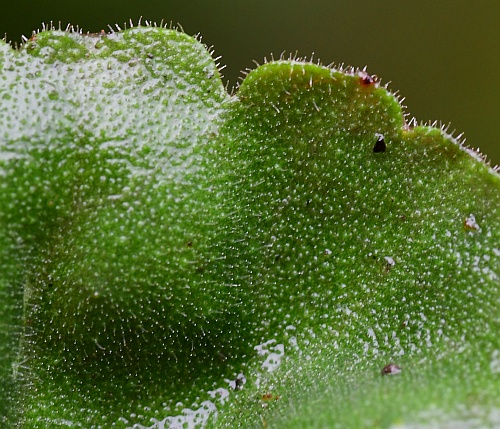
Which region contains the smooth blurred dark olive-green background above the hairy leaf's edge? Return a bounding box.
[0,0,500,165]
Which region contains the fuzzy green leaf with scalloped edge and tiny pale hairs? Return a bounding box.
[0,27,500,429]
